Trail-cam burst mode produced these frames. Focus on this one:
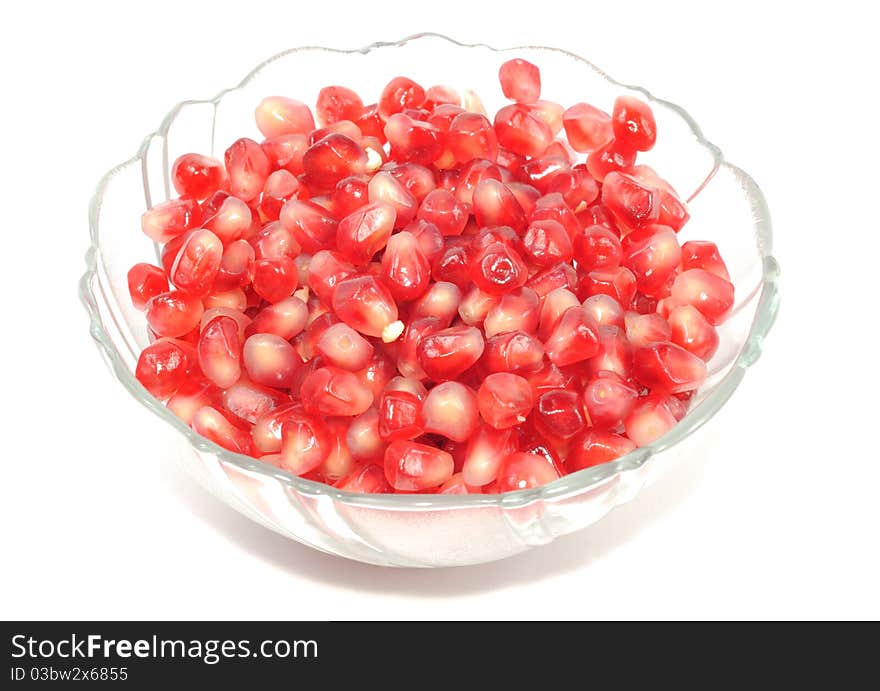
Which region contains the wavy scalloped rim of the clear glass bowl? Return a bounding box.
[79,32,779,510]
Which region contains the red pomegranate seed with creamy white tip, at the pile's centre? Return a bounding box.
[332,276,404,343]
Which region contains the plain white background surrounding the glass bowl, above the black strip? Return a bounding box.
[0,0,880,619]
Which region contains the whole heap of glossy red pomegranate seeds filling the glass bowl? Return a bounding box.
[128,60,734,494]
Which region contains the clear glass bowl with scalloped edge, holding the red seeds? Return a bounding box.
[80,34,778,567]
